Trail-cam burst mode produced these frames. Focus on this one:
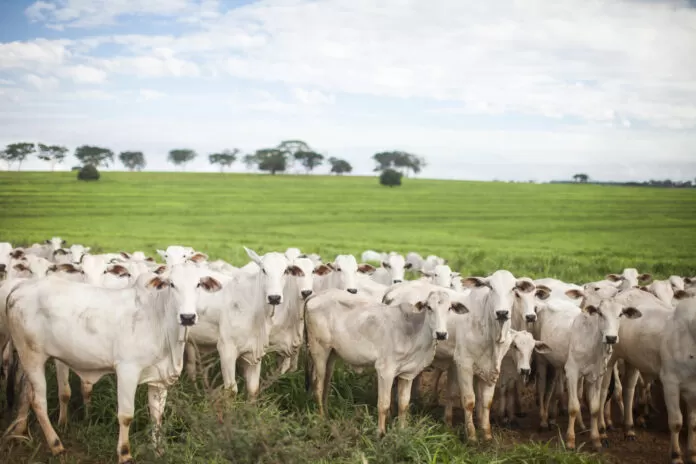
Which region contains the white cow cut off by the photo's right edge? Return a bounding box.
[660,293,696,464]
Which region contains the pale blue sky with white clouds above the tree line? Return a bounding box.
[0,0,696,181]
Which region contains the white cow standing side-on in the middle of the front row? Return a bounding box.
[305,289,467,435]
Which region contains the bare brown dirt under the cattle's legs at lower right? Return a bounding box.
[420,372,686,464]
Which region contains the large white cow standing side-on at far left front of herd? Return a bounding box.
[7,264,220,463]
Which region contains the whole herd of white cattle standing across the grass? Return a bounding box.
[0,237,696,463]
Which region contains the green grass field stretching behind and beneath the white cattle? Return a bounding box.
[0,172,696,463]
